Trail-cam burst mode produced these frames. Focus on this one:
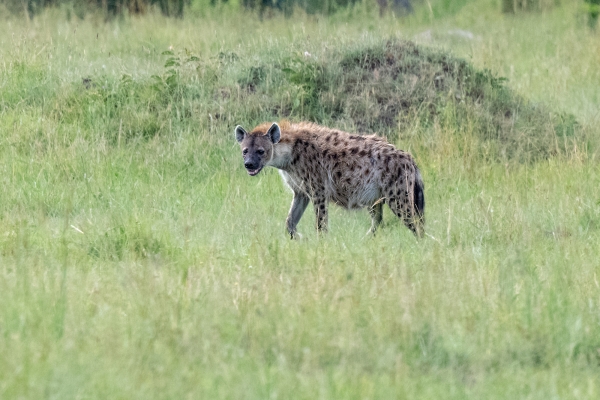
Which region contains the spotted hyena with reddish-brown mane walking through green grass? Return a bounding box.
[235,121,425,238]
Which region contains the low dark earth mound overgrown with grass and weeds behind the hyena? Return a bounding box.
[240,40,579,162]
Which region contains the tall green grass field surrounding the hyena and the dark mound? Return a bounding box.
[0,0,600,399]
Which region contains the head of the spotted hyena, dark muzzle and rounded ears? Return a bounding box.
[235,123,281,176]
